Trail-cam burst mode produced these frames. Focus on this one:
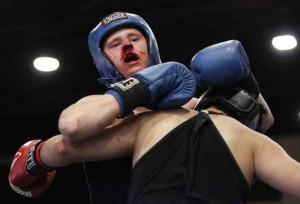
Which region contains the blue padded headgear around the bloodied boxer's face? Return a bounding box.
[88,12,161,87]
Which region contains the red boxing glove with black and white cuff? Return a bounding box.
[8,140,56,197]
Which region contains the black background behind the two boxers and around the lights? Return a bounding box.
[0,0,300,203]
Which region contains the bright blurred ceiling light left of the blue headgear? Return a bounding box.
[33,57,59,72]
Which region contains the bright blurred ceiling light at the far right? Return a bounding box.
[272,35,297,50]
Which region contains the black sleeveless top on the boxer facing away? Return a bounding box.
[127,112,250,204]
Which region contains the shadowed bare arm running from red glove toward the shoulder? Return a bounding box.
[40,126,137,168]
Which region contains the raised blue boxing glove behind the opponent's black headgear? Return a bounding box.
[190,40,260,98]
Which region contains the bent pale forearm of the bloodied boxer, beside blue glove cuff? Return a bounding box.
[58,95,120,142]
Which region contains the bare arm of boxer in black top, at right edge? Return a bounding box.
[254,133,300,198]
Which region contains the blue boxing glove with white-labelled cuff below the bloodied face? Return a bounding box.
[106,62,196,117]
